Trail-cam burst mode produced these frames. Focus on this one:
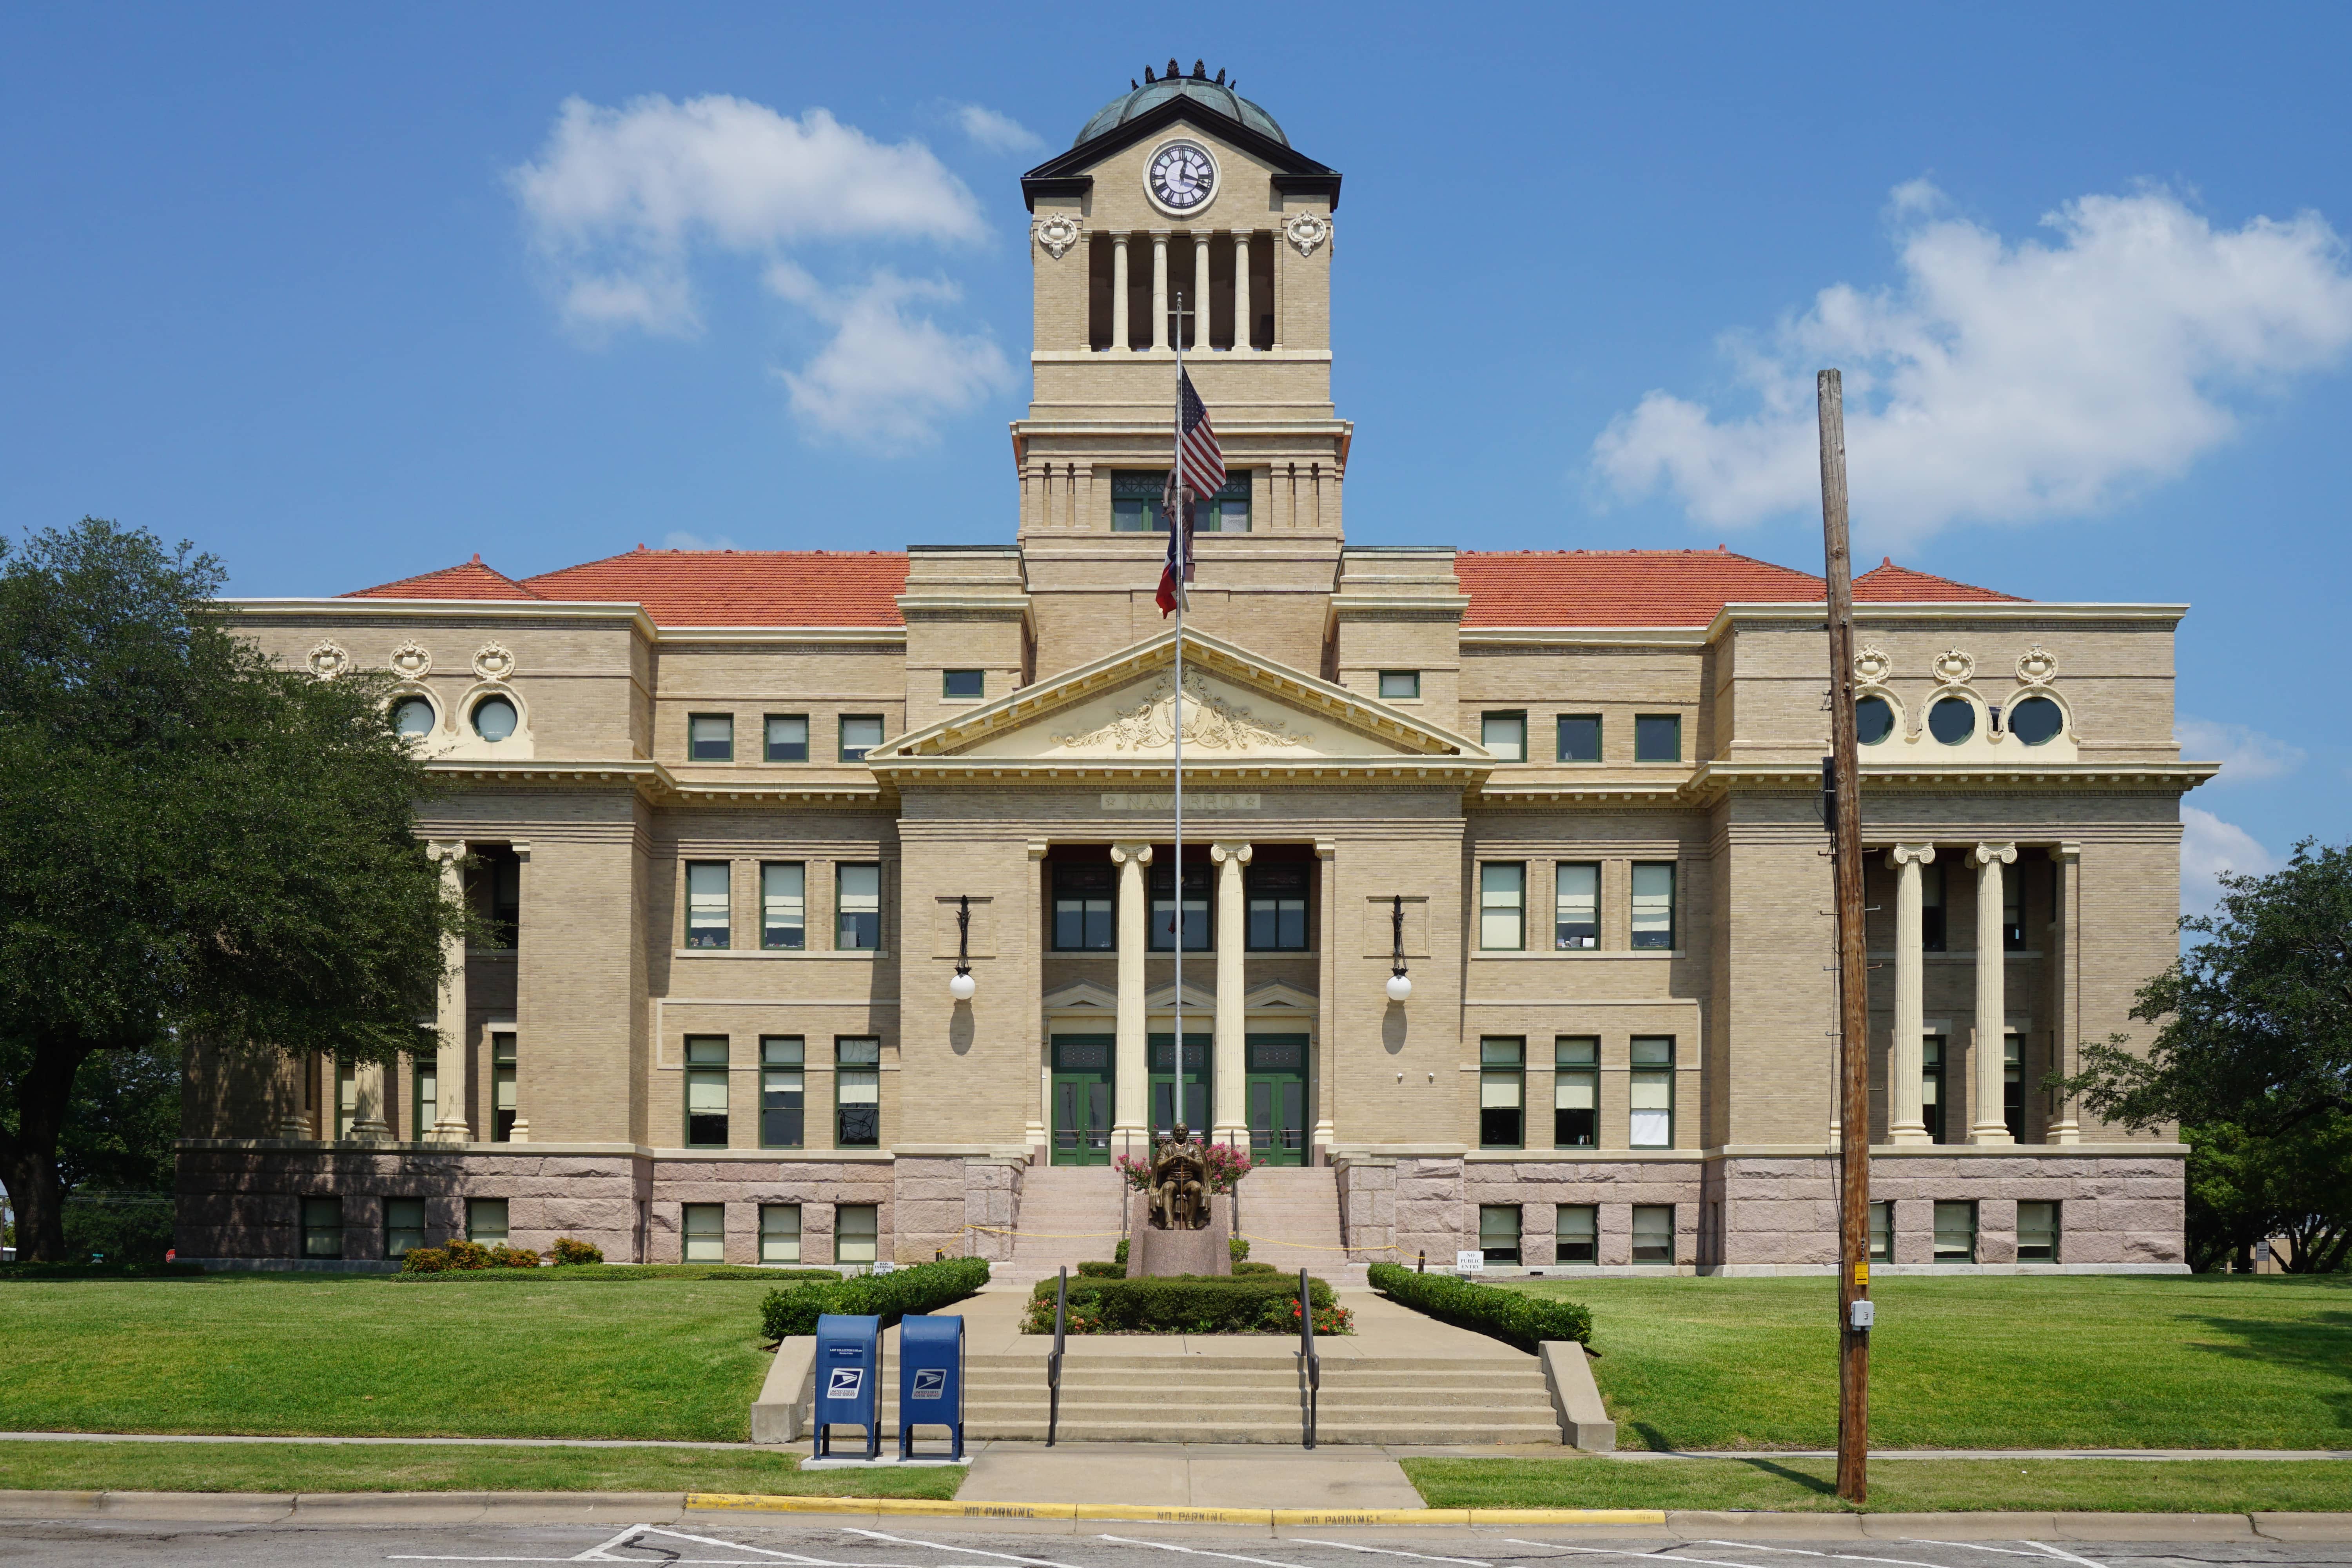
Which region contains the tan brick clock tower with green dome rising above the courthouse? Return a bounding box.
[1014,61,1352,675]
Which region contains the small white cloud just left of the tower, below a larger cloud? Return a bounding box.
[767,263,1014,449]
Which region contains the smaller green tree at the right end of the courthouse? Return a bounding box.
[2051,839,2352,1272]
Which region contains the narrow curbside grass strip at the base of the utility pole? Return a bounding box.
[1404,1460,2352,1514]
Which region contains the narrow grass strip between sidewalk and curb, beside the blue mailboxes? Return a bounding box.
[0,1432,964,1497]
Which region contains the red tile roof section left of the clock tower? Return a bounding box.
[527,545,906,625]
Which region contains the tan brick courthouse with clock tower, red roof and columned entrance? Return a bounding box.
[179,71,2216,1272]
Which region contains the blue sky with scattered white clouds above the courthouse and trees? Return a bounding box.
[0,5,2352,907]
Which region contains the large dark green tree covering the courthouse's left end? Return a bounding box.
[0,517,473,1260]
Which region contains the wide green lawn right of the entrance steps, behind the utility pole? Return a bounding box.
[1522,1274,2352,1457]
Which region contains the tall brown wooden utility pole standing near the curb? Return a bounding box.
[1818,369,1872,1502]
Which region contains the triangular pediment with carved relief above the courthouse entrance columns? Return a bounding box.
[866,630,1494,773]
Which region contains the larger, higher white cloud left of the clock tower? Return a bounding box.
[508,94,985,336]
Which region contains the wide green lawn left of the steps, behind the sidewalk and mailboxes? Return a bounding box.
[0,1269,800,1441]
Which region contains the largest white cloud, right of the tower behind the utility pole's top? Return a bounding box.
[1592,181,2352,545]
